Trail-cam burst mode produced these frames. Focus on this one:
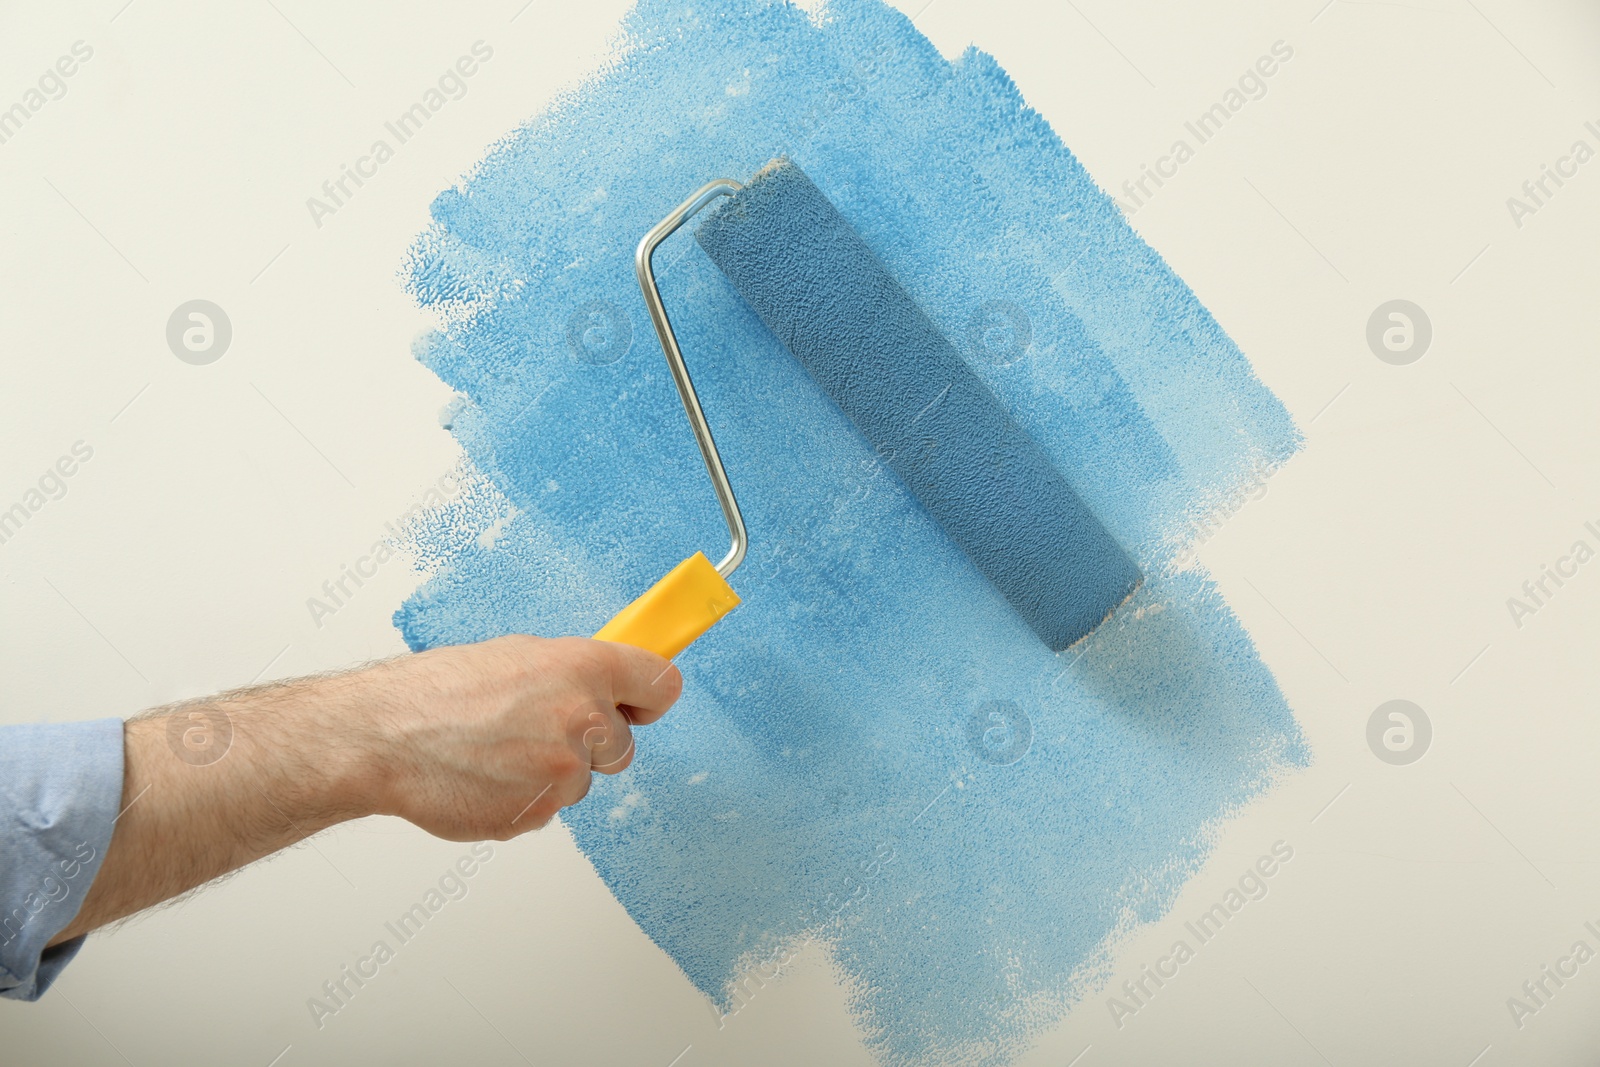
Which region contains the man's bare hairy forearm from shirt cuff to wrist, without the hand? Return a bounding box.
[51,672,382,944]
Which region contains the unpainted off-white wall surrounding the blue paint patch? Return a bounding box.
[0,0,1600,1067]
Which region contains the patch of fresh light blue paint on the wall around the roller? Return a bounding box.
[397,0,1309,1065]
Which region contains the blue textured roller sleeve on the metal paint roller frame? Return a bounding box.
[694,160,1141,651]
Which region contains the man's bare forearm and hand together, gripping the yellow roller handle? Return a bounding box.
[51,637,683,944]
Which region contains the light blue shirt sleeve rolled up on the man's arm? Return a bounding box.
[0,718,123,1000]
